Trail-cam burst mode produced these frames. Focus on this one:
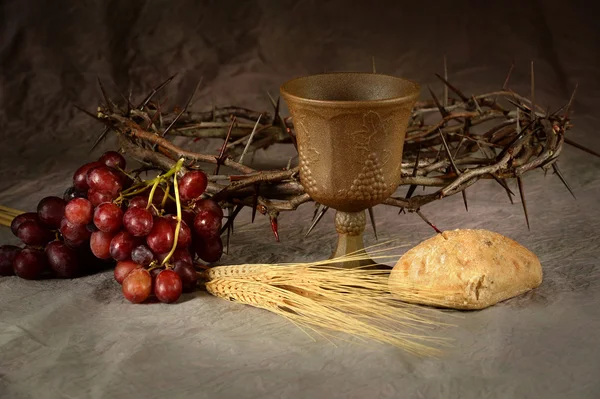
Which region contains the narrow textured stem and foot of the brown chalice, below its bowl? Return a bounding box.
[330,211,375,268]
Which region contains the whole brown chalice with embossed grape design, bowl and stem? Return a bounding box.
[280,72,420,268]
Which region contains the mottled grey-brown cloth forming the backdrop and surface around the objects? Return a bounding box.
[0,0,600,399]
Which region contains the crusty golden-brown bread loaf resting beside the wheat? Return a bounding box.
[389,230,542,309]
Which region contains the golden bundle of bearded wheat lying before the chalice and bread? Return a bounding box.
[202,245,460,356]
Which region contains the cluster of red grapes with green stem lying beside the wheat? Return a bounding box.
[0,151,223,303]
